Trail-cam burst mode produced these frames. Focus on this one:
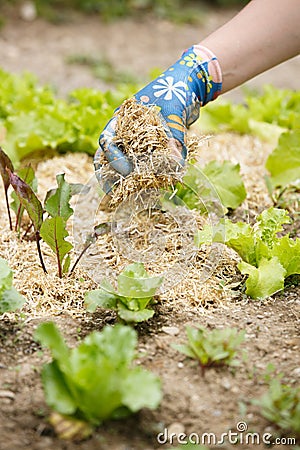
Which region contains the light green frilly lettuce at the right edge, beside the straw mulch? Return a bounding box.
[196,207,300,299]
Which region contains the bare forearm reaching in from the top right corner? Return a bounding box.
[201,0,300,93]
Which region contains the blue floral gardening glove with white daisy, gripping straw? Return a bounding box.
[94,45,222,183]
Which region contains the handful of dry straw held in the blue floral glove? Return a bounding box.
[101,98,188,208]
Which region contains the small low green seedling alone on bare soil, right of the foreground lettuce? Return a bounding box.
[172,326,245,373]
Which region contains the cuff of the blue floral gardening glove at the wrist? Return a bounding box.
[188,44,222,106]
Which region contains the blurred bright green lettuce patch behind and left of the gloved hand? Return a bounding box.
[0,69,137,164]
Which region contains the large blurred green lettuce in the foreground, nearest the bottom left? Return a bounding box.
[35,322,161,438]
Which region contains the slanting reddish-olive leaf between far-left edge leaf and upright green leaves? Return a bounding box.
[8,170,43,231]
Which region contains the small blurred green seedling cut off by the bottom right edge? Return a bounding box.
[253,377,300,436]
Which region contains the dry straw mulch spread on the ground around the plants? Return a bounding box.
[0,103,271,317]
